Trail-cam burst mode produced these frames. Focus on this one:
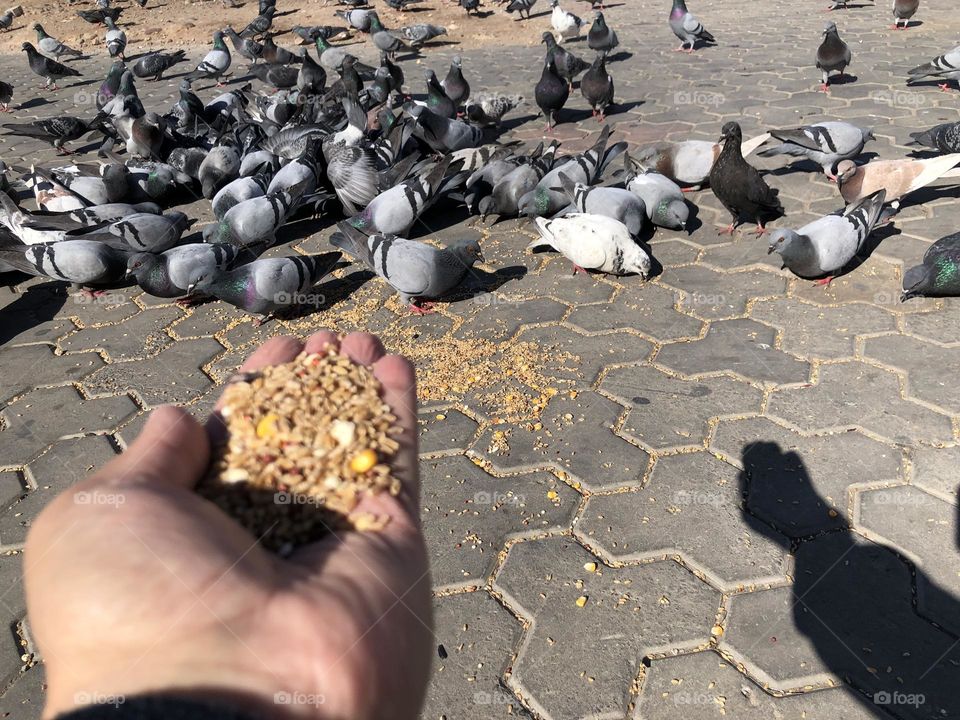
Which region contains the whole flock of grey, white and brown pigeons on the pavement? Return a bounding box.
[0,0,960,319]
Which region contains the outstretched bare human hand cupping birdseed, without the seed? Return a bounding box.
[25,332,432,720]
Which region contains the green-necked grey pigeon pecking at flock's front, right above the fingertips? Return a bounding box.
[187,252,342,324]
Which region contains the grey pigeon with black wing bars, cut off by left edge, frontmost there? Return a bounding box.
[0,240,129,286]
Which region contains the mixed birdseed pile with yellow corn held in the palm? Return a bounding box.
[198,351,400,555]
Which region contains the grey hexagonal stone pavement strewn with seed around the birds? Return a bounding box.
[0,0,960,720]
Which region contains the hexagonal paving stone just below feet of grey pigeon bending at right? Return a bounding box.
[750,298,896,359]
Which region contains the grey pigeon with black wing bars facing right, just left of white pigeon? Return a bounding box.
[330,222,483,314]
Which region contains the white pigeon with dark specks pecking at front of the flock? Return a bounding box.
[527,213,650,280]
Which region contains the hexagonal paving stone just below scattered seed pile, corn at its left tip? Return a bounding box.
[474,392,648,489]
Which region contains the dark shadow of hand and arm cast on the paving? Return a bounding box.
[739,442,960,718]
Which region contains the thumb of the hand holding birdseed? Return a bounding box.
[89,405,210,489]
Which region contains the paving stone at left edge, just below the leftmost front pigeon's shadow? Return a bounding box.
[0,345,104,402]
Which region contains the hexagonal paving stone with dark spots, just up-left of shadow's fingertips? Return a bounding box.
[600,365,763,449]
